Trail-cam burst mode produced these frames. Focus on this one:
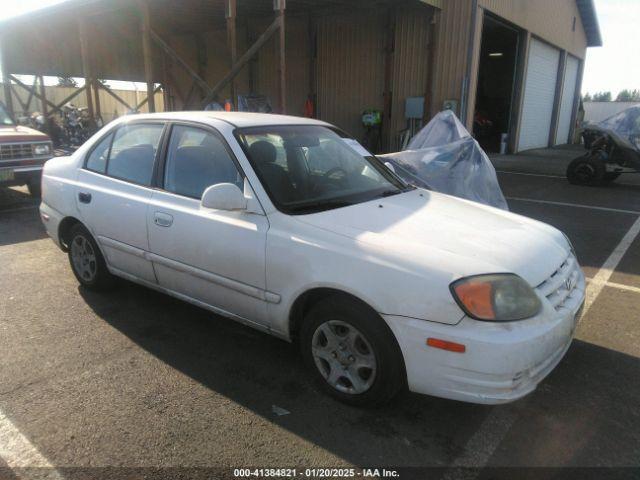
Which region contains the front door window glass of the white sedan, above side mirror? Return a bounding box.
[164,125,244,199]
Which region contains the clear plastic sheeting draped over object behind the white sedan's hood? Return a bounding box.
[380,110,509,210]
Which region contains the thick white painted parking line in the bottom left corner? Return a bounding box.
[0,410,64,480]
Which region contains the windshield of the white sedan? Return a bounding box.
[236,125,413,214]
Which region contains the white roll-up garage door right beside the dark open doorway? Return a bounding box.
[518,39,560,150]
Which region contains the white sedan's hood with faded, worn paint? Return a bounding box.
[298,189,570,286]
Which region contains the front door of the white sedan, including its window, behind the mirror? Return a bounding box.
[147,124,269,325]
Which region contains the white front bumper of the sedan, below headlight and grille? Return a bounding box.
[383,274,584,404]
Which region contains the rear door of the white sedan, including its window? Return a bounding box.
[76,122,165,283]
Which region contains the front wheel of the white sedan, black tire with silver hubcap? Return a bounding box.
[299,296,406,406]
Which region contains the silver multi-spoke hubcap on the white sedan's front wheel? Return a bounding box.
[311,320,376,394]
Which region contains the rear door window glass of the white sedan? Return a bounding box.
[107,123,164,186]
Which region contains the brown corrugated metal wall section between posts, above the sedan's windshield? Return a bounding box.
[316,12,386,138]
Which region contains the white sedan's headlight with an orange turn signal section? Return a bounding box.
[451,273,542,322]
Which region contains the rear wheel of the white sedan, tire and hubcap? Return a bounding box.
[67,223,115,291]
